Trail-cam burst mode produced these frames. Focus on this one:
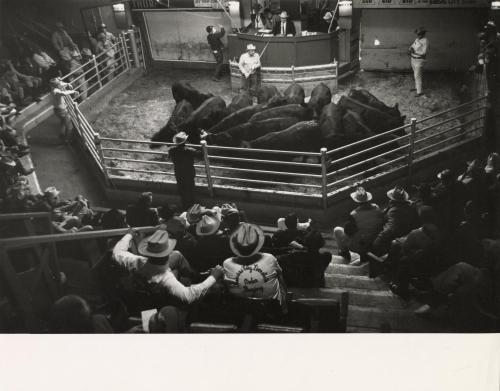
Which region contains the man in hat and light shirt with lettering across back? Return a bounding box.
[223,223,286,310]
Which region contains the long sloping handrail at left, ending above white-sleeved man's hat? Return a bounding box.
[0,226,157,249]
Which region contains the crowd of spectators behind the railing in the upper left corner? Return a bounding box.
[0,22,118,108]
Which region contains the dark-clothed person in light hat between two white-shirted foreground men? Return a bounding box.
[193,214,232,272]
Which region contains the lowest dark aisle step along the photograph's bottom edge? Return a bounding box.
[347,305,447,333]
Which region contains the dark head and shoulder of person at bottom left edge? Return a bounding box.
[49,295,113,334]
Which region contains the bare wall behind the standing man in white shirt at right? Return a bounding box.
[360,8,487,71]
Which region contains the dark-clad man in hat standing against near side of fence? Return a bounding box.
[168,132,199,210]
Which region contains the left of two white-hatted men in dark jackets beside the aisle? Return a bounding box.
[333,186,384,261]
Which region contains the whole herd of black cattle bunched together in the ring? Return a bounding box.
[151,81,404,152]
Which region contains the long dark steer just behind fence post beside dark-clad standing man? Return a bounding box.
[207,117,297,147]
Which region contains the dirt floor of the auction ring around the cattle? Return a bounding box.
[93,70,472,194]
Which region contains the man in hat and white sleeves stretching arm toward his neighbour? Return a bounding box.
[113,229,223,304]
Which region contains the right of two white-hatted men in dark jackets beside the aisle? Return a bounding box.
[373,186,418,255]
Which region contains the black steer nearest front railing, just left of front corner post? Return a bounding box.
[242,121,321,152]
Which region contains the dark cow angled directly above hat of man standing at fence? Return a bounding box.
[178,96,227,144]
